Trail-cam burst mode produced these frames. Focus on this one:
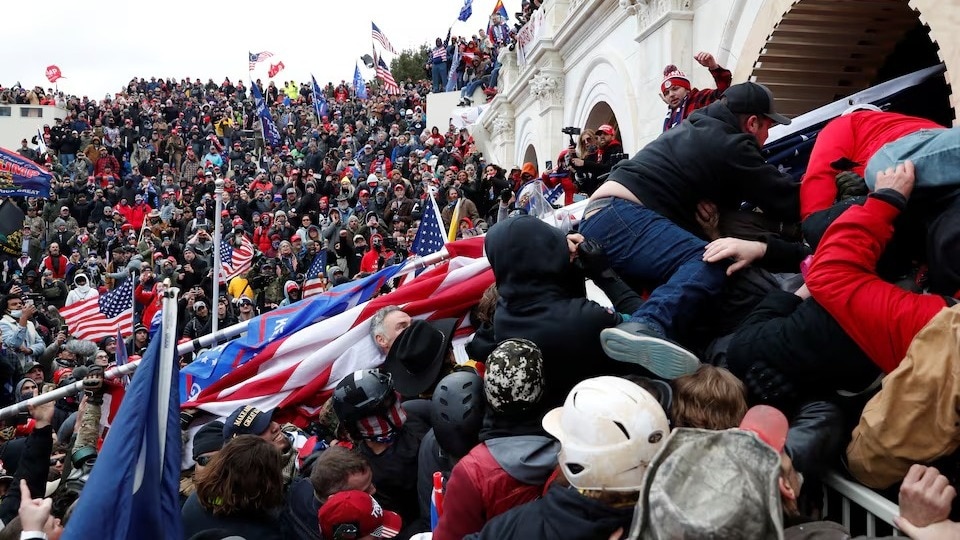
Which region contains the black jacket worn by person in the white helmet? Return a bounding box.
[466,485,633,540]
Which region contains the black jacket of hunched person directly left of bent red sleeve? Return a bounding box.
[727,290,880,411]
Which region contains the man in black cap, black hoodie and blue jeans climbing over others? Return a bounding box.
[580,83,799,379]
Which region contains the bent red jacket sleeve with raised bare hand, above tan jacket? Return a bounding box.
[806,195,947,373]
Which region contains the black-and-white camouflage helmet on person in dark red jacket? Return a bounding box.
[483,339,543,414]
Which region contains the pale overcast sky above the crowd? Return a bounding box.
[0,0,520,99]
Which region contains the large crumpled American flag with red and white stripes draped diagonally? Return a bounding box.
[181,237,493,421]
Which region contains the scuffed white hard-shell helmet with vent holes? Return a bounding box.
[543,377,670,491]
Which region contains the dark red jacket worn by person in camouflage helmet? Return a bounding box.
[433,444,543,540]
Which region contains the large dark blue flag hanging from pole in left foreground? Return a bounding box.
[63,316,183,540]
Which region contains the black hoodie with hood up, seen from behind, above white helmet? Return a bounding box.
[485,216,626,406]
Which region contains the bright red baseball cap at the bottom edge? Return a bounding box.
[317,490,403,538]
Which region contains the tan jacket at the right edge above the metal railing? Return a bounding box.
[847,305,960,489]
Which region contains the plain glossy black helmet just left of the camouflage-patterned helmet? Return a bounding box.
[430,371,487,459]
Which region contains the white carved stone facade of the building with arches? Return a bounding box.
[472,0,960,169]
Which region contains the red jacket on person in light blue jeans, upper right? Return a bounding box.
[800,111,943,219]
